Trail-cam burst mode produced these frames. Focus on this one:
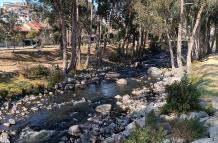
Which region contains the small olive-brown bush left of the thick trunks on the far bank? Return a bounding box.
[48,66,64,87]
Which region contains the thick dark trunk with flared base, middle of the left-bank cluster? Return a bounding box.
[67,0,78,73]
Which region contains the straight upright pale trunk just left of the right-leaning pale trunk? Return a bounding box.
[177,0,184,70]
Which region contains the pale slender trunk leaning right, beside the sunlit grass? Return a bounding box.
[186,5,204,73]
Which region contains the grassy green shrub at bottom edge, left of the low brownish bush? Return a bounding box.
[125,114,164,143]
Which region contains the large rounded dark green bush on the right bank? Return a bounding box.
[162,78,200,113]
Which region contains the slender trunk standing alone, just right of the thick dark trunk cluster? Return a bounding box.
[86,0,93,67]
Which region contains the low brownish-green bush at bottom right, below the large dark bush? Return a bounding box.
[172,120,206,142]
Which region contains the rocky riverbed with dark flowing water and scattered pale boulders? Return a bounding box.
[0,52,184,143]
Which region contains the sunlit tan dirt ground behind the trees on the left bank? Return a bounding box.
[0,45,114,72]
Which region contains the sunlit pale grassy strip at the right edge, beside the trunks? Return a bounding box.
[192,55,218,96]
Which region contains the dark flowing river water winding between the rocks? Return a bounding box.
[0,52,171,143]
